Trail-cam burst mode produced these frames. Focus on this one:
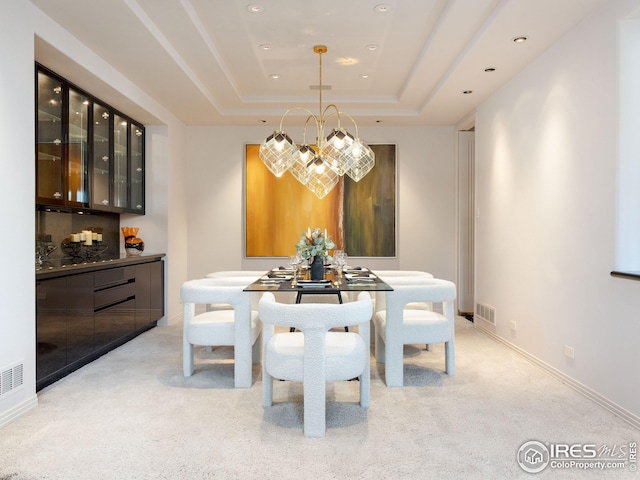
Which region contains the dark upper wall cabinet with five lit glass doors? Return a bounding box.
[36,64,145,215]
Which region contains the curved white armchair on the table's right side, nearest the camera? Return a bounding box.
[373,277,456,387]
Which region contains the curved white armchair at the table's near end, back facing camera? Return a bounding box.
[259,292,373,437]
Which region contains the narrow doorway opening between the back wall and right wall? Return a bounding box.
[457,128,475,318]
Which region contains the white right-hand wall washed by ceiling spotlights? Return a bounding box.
[475,0,640,418]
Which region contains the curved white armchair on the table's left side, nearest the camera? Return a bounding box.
[180,277,261,388]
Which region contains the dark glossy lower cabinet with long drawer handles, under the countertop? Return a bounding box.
[36,259,164,391]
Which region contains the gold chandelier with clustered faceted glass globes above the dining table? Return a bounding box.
[260,45,375,198]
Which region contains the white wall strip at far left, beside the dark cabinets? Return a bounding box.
[0,1,36,426]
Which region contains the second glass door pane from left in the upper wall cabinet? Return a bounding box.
[67,89,91,203]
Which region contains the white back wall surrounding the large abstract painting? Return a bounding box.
[186,127,456,280]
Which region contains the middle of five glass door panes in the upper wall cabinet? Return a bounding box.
[91,103,111,207]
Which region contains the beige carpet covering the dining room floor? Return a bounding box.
[0,318,640,480]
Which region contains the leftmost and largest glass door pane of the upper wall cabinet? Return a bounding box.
[36,72,64,203]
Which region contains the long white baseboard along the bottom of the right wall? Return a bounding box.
[475,322,640,430]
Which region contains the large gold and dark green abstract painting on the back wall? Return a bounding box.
[244,144,396,257]
